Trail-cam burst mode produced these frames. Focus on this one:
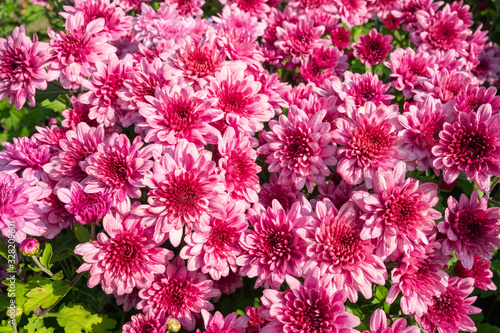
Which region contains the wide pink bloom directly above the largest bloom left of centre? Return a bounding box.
[138,85,223,146]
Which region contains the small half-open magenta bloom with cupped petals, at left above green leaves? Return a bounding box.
[57,181,112,225]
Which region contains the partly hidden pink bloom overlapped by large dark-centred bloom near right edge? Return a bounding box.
[398,96,455,174]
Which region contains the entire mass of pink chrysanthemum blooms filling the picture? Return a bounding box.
[0,0,500,333]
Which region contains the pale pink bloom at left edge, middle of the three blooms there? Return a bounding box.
[0,136,53,179]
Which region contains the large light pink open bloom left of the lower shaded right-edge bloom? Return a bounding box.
[352,162,441,258]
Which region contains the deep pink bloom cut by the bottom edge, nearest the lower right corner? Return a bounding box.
[415,276,481,333]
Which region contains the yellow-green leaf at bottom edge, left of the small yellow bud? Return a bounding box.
[53,303,116,333]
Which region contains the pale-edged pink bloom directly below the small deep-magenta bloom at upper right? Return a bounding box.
[333,71,394,115]
